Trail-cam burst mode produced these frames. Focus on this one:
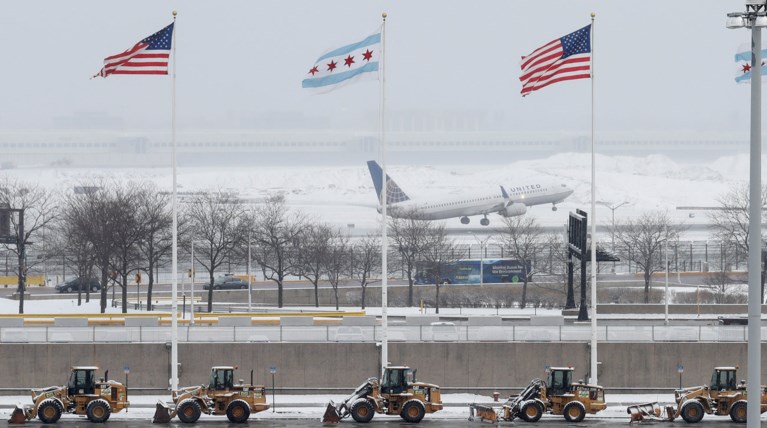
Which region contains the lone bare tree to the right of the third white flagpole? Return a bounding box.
[611,211,683,303]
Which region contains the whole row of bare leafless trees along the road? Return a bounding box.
[0,178,760,313]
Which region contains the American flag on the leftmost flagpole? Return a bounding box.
[93,24,173,77]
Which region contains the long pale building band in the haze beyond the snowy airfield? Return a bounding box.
[0,129,748,169]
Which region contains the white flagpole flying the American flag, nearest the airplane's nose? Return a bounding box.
[589,12,598,385]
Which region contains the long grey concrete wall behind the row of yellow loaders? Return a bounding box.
[0,342,767,394]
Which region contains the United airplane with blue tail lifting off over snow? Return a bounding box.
[368,161,573,226]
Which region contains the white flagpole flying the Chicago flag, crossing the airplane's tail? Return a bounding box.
[380,12,389,376]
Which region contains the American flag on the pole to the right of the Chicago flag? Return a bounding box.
[519,25,591,97]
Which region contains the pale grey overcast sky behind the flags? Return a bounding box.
[0,0,750,132]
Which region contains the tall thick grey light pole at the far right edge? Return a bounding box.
[726,0,767,428]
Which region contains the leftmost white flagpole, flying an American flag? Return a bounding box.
[170,10,180,391]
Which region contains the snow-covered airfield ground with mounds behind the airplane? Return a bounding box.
[0,153,748,239]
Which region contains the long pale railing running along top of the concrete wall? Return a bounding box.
[0,325,767,344]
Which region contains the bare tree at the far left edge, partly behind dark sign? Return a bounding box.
[0,177,57,314]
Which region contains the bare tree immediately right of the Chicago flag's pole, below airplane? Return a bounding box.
[389,210,430,306]
